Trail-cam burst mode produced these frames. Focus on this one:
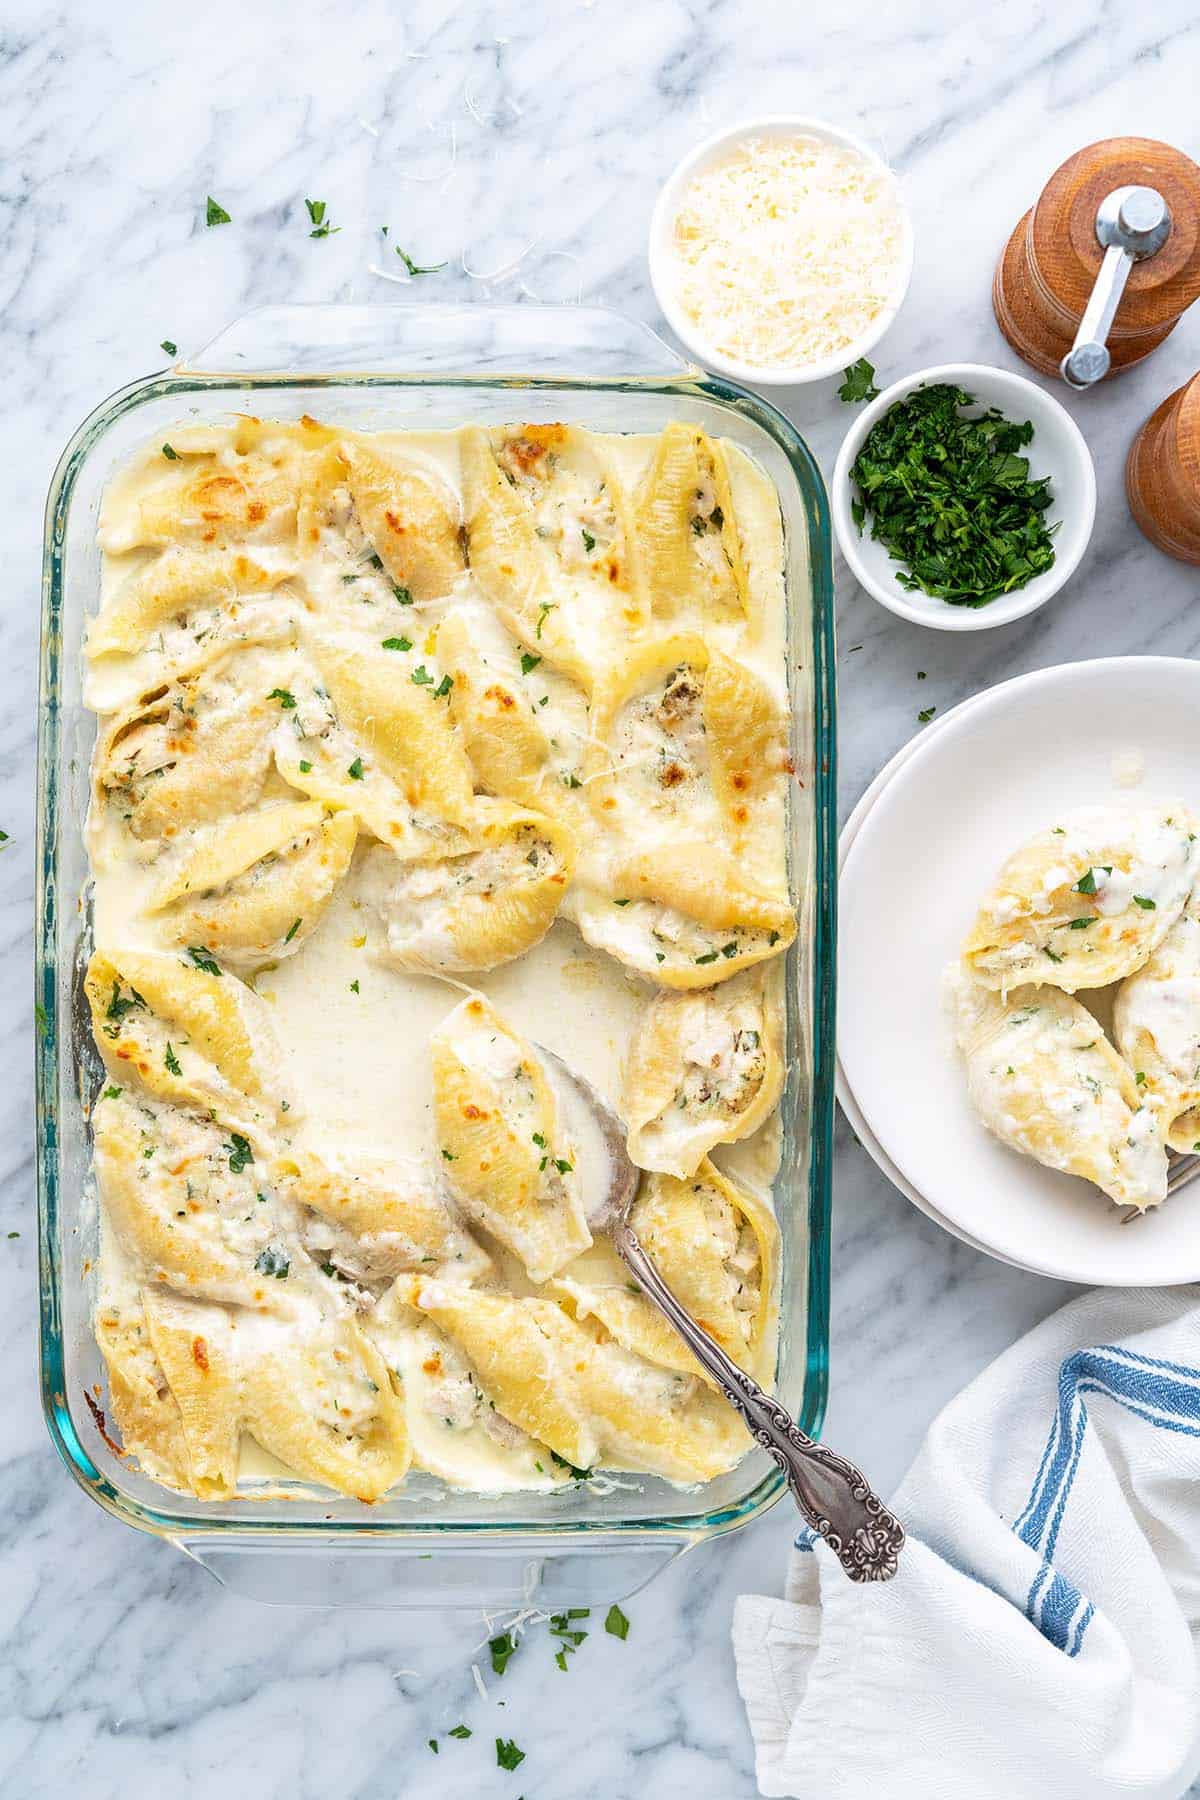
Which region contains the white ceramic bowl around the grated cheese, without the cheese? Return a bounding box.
[649,113,912,387]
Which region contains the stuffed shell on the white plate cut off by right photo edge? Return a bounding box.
[1112,893,1200,1152]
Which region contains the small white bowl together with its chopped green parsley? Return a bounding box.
[833,362,1096,632]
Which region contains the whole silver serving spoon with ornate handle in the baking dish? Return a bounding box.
[536,1044,905,1582]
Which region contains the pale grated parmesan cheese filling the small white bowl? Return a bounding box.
[673,137,903,369]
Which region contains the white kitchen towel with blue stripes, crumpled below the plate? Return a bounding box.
[734,1288,1200,1800]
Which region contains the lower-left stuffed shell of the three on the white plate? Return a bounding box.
[952,970,1166,1210]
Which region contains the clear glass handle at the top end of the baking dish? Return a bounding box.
[184,301,698,382]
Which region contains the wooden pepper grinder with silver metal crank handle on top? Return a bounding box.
[991,137,1200,387]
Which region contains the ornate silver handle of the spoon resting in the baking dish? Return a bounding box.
[612,1220,905,1580]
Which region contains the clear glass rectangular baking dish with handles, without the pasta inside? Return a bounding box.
[36,306,837,1611]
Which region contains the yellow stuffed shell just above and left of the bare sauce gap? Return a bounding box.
[151,801,358,970]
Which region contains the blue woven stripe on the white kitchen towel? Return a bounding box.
[1013,1345,1200,1656]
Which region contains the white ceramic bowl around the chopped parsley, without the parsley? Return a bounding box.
[831,362,1096,632]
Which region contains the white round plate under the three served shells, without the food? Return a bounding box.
[838,657,1200,1287]
